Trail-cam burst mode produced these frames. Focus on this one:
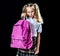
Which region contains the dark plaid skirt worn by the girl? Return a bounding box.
[17,37,37,56]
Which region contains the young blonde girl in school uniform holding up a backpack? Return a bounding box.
[17,3,43,56]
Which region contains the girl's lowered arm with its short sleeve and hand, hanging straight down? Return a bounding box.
[35,25,42,54]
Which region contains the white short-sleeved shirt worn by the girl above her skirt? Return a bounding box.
[26,18,42,37]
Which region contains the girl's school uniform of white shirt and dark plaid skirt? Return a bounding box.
[17,18,42,56]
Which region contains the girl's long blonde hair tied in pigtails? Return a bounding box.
[22,3,43,24]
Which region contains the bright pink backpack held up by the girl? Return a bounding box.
[10,20,32,49]
